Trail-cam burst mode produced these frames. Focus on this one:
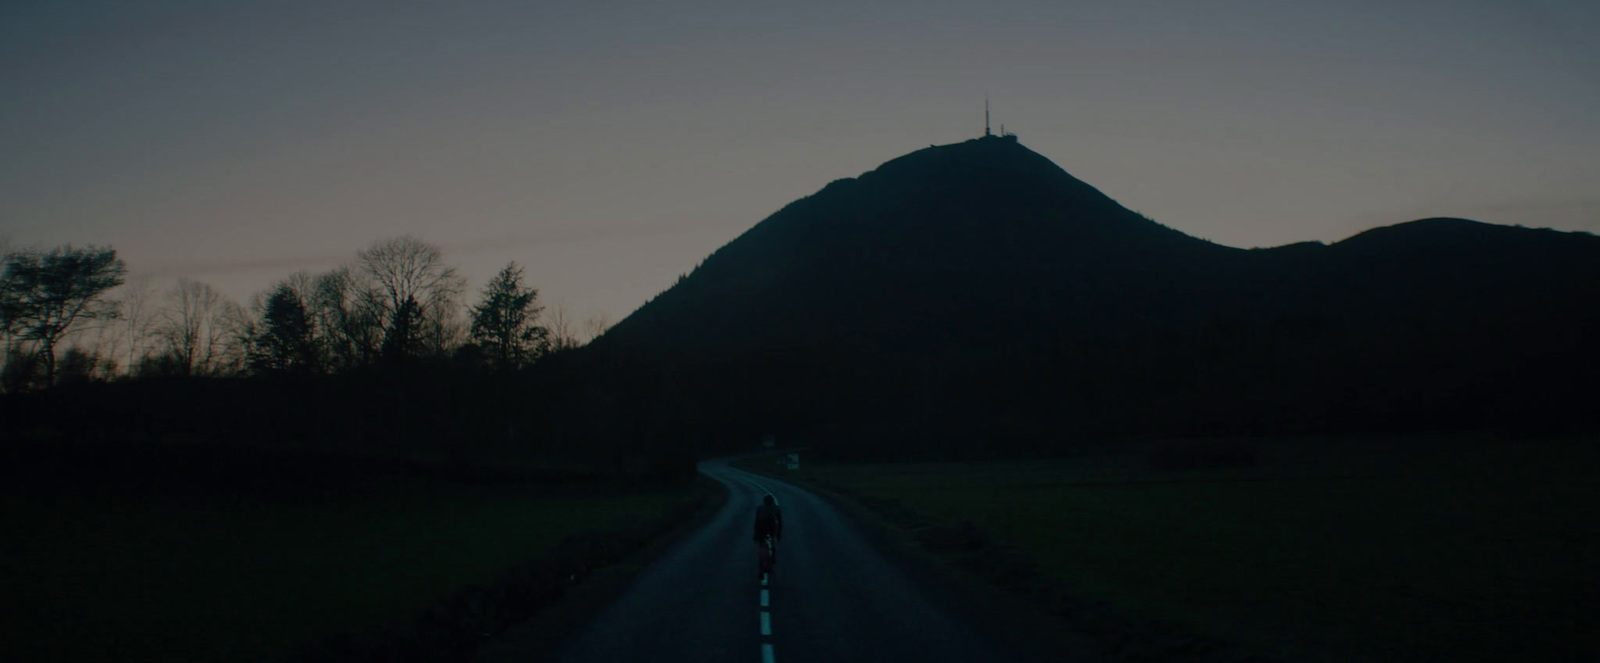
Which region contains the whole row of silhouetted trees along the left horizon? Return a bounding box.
[0,237,605,392]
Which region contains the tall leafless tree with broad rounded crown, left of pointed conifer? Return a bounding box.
[355,235,467,360]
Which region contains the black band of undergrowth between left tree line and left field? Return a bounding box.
[0,344,694,485]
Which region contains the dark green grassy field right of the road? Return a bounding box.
[805,439,1600,661]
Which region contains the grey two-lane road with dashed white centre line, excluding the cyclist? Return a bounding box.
[512,461,1059,663]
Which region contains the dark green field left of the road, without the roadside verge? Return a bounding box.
[0,467,700,661]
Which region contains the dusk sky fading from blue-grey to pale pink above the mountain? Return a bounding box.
[0,0,1600,322]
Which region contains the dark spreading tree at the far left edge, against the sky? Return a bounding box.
[0,245,126,384]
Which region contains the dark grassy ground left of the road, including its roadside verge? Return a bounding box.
[0,445,710,661]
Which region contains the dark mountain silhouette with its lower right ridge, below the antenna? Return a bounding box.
[587,136,1600,458]
